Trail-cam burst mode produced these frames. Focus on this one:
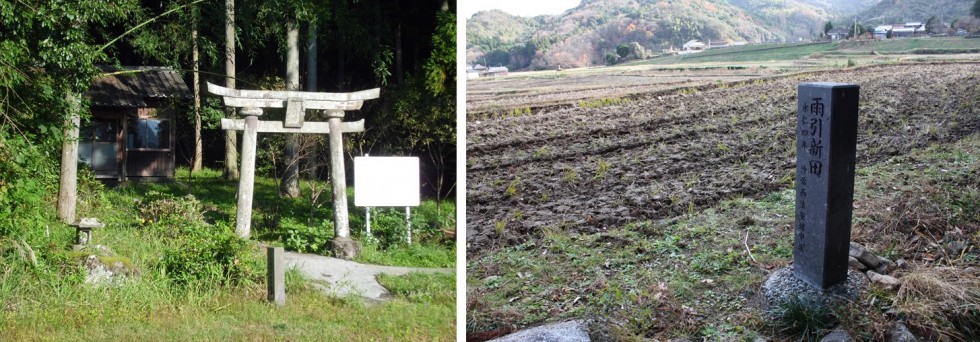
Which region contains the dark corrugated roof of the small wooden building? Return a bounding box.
[85,66,193,108]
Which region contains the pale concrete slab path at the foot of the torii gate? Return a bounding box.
[283,252,455,300]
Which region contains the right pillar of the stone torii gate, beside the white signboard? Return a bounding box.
[327,110,360,260]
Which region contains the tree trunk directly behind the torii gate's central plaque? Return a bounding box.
[279,20,300,198]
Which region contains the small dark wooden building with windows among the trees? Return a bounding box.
[78,66,192,181]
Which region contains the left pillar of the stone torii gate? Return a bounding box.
[232,108,262,239]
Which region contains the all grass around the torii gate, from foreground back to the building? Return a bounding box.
[0,170,456,341]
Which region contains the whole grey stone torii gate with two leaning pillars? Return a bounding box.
[208,82,381,259]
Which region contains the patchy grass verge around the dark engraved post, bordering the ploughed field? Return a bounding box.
[466,135,980,340]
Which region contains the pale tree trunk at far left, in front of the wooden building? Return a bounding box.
[58,94,81,224]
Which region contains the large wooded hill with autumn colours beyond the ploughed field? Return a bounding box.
[466,0,876,69]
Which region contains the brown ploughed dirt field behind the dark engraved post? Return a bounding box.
[466,63,980,256]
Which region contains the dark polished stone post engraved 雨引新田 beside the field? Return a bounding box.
[793,83,860,289]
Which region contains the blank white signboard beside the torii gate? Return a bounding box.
[354,157,420,207]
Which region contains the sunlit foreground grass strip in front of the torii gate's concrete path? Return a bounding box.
[0,232,455,341]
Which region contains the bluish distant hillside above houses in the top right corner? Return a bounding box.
[858,0,974,24]
